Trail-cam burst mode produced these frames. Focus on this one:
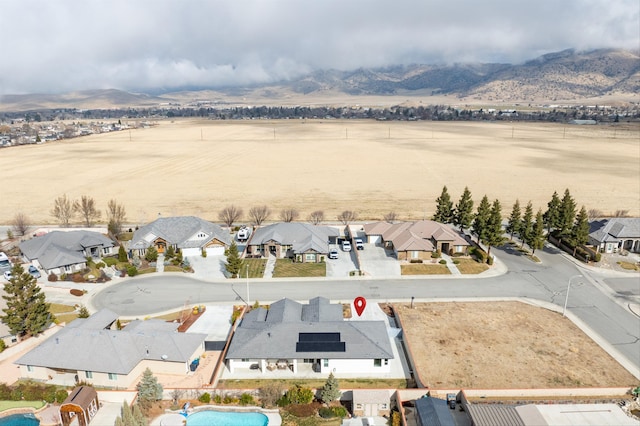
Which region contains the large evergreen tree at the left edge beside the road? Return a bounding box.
[0,263,51,337]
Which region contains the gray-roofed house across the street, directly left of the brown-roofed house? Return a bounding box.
[246,222,339,262]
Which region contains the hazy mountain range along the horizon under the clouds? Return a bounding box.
[0,49,640,111]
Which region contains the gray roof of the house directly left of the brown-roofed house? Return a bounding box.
[249,222,339,253]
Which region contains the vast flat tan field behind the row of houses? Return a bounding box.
[0,120,640,224]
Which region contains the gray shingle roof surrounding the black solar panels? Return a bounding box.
[227,297,393,359]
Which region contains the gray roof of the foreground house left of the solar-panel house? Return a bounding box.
[15,311,207,374]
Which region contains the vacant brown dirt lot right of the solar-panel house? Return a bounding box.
[394,302,637,389]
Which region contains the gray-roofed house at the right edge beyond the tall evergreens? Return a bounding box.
[588,217,640,253]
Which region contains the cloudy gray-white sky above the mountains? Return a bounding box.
[0,0,640,94]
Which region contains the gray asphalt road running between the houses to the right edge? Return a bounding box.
[90,241,640,378]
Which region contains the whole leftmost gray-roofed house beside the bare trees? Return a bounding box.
[19,230,117,275]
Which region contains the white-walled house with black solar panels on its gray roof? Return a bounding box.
[225,297,394,377]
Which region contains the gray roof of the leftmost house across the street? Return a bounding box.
[20,230,114,269]
